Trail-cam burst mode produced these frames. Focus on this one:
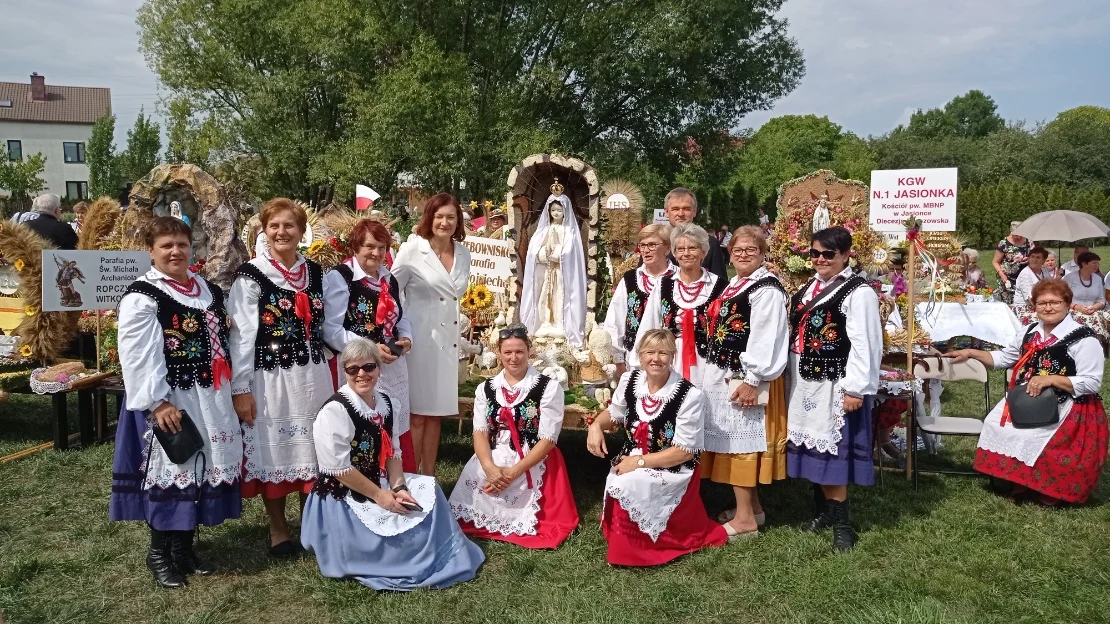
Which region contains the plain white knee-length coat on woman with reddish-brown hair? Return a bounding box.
[391,236,471,416]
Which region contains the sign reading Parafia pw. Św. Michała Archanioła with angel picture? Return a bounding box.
[42,249,150,312]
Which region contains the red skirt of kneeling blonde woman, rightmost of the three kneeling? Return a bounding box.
[602,466,728,566]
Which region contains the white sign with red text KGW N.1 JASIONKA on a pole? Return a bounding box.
[870,168,957,232]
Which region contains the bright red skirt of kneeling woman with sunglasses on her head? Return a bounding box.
[458,446,578,548]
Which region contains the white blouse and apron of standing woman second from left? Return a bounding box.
[228,250,344,483]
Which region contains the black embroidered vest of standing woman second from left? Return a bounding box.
[235,260,324,371]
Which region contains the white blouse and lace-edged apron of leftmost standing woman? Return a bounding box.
[118,269,243,489]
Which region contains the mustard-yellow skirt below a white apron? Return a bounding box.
[702,375,786,487]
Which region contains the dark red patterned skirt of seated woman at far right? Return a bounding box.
[975,400,1107,503]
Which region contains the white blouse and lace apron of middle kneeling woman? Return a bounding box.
[450,366,563,535]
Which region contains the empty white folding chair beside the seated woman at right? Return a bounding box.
[906,356,990,489]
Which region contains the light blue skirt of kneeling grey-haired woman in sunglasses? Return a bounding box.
[301,486,485,592]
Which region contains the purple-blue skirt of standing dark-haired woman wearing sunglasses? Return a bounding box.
[786,396,875,485]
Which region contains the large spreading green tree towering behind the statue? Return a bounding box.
[138,0,804,200]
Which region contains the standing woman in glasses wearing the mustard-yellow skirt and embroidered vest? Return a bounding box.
[699,225,790,536]
